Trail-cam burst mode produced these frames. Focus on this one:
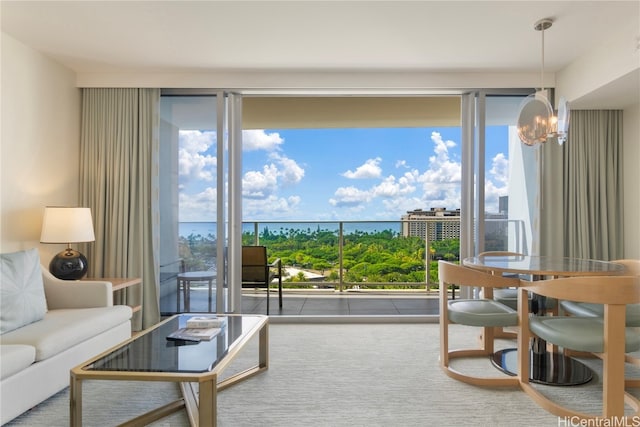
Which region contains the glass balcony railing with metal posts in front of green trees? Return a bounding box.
[175,221,524,292]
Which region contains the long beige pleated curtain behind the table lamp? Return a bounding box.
[80,88,160,329]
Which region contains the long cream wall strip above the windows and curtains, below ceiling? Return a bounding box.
[78,70,554,91]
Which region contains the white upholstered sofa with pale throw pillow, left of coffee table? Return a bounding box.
[0,249,132,424]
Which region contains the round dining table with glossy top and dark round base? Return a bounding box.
[462,255,625,385]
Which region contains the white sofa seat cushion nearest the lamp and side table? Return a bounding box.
[2,305,132,361]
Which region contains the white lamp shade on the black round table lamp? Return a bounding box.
[40,206,96,244]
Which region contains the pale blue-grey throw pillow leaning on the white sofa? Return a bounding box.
[0,248,47,334]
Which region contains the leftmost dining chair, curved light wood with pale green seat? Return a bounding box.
[438,261,520,386]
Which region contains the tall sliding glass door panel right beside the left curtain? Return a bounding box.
[159,91,240,314]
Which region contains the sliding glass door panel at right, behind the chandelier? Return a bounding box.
[462,92,540,256]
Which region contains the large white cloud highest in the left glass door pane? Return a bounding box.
[178,130,217,185]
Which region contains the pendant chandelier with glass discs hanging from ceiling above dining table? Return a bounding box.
[518,18,569,146]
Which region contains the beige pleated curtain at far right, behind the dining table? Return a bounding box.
[563,110,624,260]
